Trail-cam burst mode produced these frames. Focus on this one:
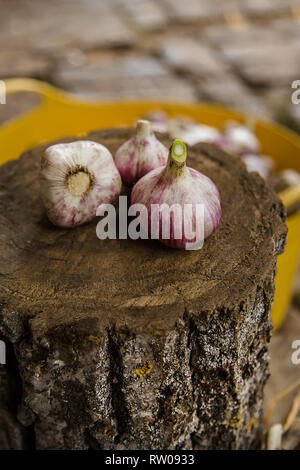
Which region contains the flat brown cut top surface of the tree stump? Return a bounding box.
[0,129,285,336]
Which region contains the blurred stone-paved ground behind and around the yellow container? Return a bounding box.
[0,0,300,449]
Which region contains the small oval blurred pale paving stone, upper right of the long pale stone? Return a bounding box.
[160,36,228,76]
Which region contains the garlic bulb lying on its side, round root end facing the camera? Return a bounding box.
[40,140,122,227]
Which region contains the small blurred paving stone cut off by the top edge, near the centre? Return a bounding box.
[114,0,168,31]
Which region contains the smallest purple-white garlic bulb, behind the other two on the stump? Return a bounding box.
[115,120,168,186]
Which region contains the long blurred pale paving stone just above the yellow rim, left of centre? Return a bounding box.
[52,55,197,101]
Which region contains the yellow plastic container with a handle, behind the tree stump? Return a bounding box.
[0,78,300,329]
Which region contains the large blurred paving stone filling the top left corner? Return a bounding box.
[0,0,134,52]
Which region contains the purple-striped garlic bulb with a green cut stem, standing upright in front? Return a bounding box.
[131,139,221,249]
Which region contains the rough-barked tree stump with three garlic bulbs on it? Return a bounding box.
[0,130,286,449]
